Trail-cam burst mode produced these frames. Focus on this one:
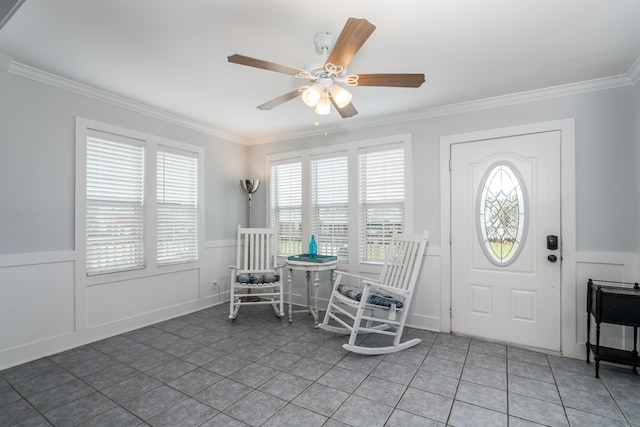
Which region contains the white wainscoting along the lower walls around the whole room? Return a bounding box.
[0,249,640,369]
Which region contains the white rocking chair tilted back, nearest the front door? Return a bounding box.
[319,231,429,355]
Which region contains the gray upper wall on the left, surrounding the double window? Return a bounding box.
[0,73,247,255]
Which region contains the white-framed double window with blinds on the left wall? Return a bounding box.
[76,118,203,283]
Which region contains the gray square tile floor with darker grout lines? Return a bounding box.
[0,305,640,427]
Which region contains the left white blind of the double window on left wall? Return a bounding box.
[86,134,144,275]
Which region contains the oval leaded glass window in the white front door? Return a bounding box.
[476,162,528,266]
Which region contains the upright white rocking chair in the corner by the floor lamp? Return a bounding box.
[229,226,284,319]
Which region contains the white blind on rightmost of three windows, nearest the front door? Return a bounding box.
[359,148,404,262]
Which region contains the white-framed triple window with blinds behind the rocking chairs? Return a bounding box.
[267,134,411,272]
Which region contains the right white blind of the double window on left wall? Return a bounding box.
[156,147,198,265]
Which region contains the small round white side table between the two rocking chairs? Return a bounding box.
[286,255,338,328]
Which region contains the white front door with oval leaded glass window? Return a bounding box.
[451,131,561,351]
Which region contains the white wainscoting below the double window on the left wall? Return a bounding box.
[0,241,235,370]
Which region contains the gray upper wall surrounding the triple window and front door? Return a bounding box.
[249,86,640,253]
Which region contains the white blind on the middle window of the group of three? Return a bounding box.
[311,155,349,261]
